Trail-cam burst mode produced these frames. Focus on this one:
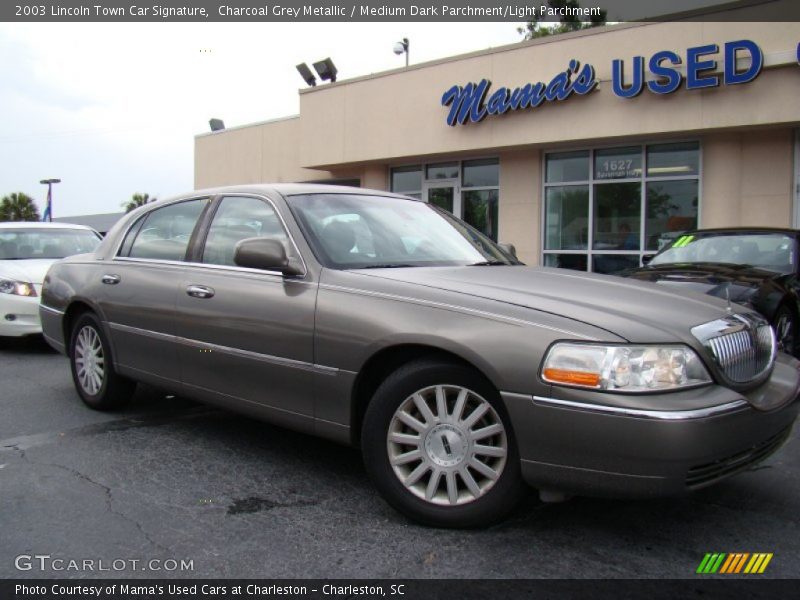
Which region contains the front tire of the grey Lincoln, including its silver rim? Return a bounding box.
[361,359,525,527]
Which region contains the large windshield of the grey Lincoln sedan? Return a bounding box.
[288,194,520,269]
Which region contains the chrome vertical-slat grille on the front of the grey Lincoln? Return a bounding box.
[692,313,776,384]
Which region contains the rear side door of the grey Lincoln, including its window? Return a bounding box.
[101,198,209,384]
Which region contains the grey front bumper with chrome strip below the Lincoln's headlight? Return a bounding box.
[502,356,800,497]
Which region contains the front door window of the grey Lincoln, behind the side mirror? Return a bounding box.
[202,196,291,266]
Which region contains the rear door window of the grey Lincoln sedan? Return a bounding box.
[125,198,207,260]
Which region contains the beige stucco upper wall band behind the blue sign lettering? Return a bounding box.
[300,23,800,166]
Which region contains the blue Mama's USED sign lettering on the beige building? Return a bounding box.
[442,40,768,126]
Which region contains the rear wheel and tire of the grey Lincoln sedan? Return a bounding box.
[69,313,136,411]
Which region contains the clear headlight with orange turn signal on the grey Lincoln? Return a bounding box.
[542,342,711,393]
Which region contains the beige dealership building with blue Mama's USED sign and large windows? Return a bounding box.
[195,9,800,272]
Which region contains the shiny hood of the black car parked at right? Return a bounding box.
[621,263,781,304]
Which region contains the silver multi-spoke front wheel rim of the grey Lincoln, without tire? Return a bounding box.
[386,385,508,506]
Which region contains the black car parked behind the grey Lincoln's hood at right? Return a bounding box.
[619,227,800,356]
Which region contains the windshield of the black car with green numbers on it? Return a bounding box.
[650,232,797,273]
